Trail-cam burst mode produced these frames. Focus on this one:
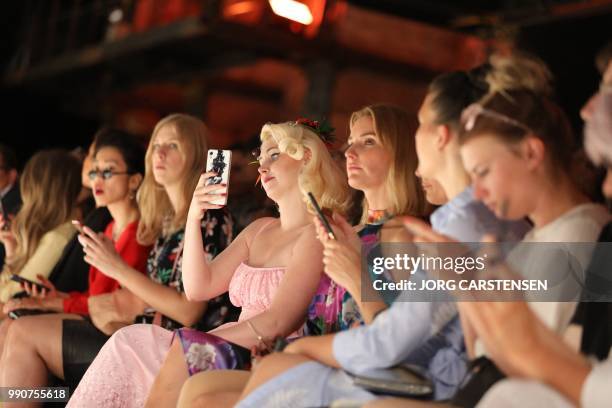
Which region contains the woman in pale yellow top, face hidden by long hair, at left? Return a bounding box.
[0,150,81,303]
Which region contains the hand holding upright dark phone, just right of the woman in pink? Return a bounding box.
[314,213,361,295]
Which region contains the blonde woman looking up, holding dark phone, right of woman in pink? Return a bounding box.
[178,104,436,407]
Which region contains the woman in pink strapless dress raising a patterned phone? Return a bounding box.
[68,122,349,408]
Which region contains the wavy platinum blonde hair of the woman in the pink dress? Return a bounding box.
[260,122,350,215]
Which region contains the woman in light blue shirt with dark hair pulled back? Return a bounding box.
[204,58,547,406]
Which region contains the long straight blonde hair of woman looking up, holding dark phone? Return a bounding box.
[349,104,429,223]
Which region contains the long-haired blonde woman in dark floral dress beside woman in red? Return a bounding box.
[0,114,237,402]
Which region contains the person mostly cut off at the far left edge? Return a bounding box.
[0,144,21,270]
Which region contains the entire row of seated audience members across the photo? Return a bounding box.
[0,44,612,408]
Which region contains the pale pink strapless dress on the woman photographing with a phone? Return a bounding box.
[67,263,285,408]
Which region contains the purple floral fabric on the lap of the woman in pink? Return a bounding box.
[176,328,251,376]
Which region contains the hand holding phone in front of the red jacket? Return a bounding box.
[78,227,126,280]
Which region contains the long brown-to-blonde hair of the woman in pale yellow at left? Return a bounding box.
[3,150,81,274]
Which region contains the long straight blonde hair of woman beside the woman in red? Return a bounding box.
[137,113,208,245]
